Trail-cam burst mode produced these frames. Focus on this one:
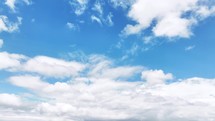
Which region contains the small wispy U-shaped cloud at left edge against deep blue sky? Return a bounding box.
[0,15,22,33]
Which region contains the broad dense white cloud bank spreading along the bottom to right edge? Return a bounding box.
[5,75,215,121]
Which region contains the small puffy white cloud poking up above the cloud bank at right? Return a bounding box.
[141,70,173,85]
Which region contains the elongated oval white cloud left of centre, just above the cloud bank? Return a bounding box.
[21,56,85,78]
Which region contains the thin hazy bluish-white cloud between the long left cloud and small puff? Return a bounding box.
[85,55,143,79]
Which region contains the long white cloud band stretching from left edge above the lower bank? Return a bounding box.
[0,52,85,78]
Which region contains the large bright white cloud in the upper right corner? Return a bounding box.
[122,0,215,38]
